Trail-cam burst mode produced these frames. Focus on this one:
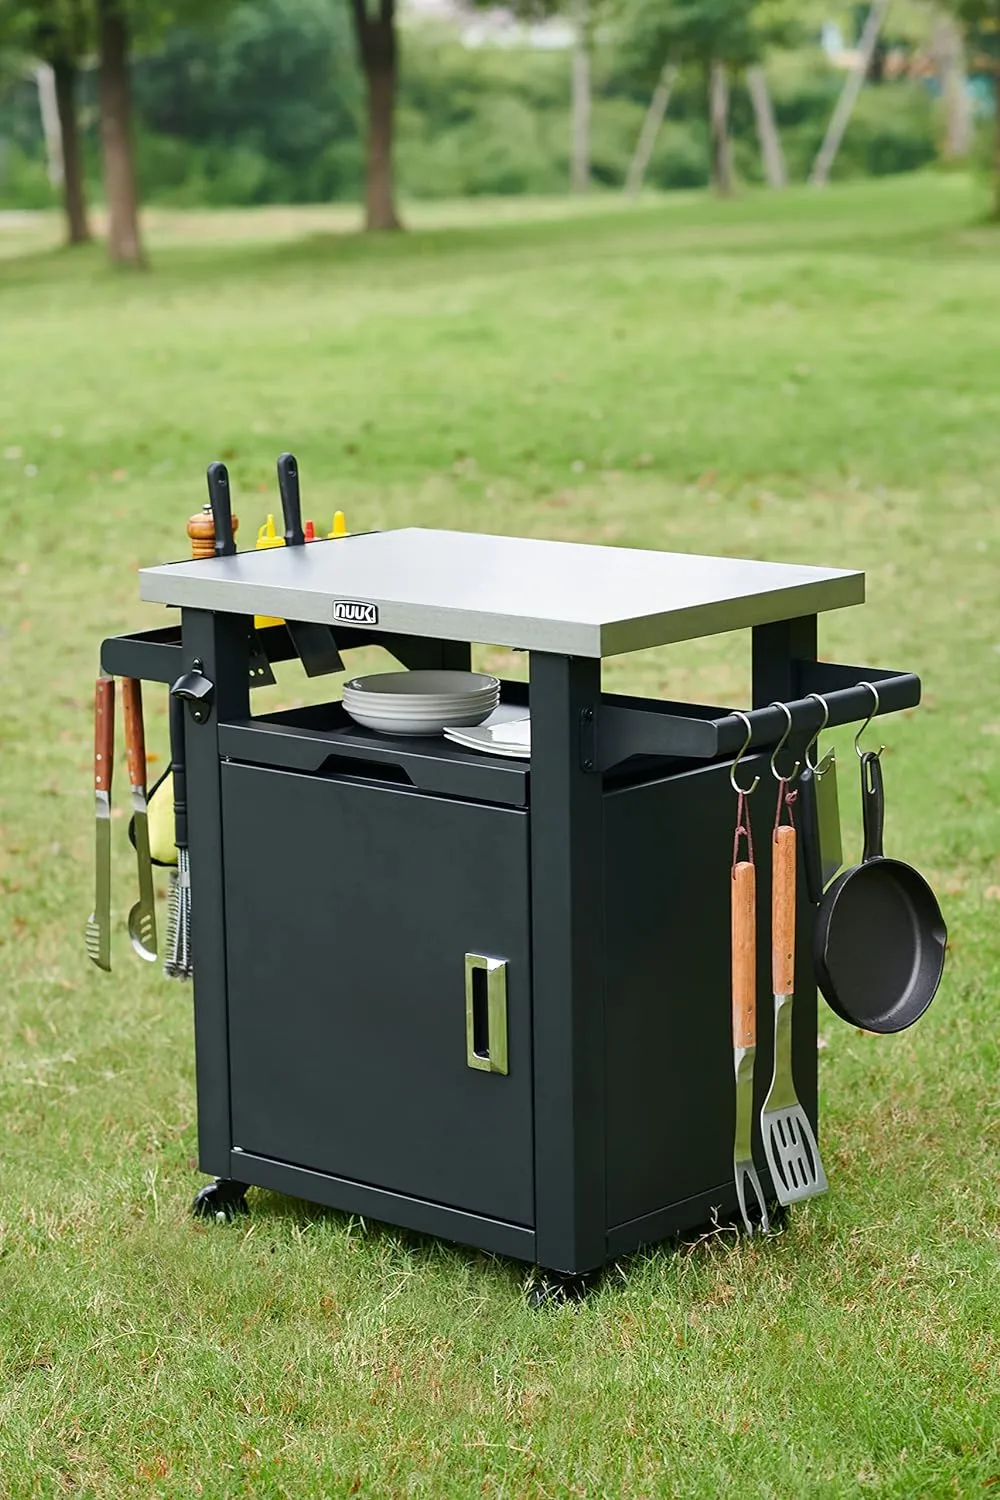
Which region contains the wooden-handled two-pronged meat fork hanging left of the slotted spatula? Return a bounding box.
[729,713,768,1235]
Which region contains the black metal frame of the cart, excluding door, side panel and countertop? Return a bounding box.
[100,609,921,1275]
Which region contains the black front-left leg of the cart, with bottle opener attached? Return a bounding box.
[181,609,250,1178]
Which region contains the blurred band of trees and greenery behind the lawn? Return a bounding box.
[0,0,1000,255]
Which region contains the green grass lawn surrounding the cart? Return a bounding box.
[0,179,1000,1500]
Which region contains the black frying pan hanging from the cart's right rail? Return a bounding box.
[813,750,948,1032]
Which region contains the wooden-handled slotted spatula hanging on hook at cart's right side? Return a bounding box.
[760,704,826,1203]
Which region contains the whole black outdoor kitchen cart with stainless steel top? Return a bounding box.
[102,530,919,1275]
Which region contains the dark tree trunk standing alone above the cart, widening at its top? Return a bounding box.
[351,0,402,230]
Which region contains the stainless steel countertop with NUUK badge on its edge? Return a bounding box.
[139,528,865,657]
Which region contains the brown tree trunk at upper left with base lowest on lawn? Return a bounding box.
[97,0,145,266]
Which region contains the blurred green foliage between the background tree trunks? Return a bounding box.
[0,0,936,207]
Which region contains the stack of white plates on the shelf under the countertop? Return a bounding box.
[343,672,499,735]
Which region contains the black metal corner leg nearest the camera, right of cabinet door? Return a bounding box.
[529,651,607,1274]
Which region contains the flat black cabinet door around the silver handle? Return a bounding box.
[222,765,534,1226]
